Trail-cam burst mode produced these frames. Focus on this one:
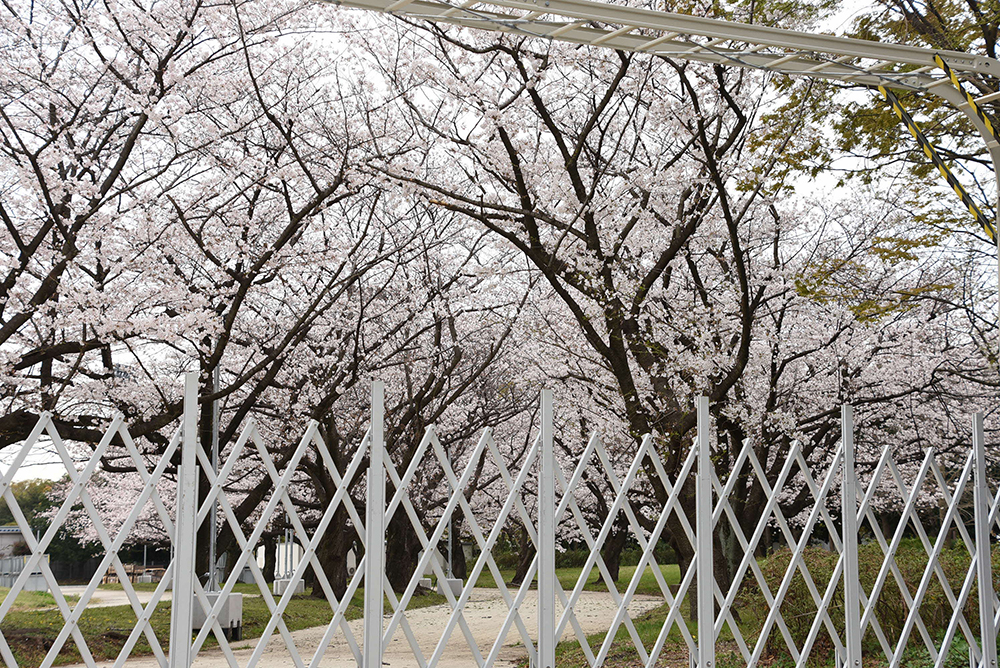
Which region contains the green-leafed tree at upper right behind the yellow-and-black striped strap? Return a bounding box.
[751,0,1000,376]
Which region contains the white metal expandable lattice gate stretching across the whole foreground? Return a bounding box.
[0,374,1000,668]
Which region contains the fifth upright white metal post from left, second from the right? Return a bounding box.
[840,406,861,668]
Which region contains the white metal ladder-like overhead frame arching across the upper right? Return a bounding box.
[319,0,1000,192]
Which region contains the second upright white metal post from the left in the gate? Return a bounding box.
[364,380,385,668]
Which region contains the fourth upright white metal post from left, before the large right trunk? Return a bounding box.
[695,397,715,668]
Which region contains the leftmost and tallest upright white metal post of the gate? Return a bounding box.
[170,371,198,668]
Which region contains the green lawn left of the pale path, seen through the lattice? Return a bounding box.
[0,584,445,666]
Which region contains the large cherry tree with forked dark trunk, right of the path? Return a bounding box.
[342,3,982,582]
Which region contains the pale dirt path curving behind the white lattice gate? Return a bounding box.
[90,589,662,668]
